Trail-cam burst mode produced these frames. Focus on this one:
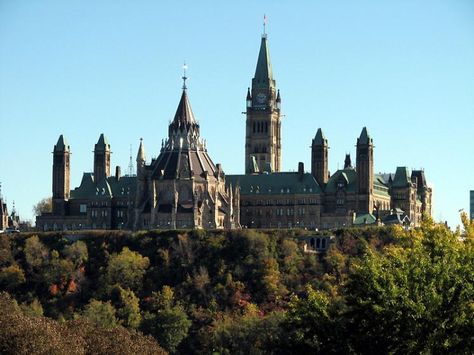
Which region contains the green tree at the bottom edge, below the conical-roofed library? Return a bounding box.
[143,286,191,353]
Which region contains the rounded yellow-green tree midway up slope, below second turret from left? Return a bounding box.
[105,247,150,292]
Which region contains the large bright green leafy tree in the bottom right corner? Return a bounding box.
[345,220,474,353]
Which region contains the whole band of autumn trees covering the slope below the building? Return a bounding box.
[0,220,474,354]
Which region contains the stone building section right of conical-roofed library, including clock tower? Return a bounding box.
[227,34,432,229]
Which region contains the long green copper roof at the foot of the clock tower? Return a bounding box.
[226,172,321,195]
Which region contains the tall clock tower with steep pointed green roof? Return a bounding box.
[245,33,281,174]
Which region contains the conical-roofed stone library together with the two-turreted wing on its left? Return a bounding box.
[36,82,240,230]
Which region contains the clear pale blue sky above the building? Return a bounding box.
[0,0,474,226]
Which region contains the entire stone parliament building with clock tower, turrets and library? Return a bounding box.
[36,30,432,231]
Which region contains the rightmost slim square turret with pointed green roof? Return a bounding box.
[356,127,374,213]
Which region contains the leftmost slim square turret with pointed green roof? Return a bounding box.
[53,135,71,215]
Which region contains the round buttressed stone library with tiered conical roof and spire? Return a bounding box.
[134,84,239,229]
